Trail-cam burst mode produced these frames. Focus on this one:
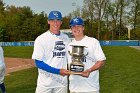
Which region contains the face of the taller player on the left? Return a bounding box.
[48,19,62,31]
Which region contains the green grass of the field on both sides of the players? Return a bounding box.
[1,46,140,93]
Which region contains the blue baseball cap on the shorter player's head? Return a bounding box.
[69,17,84,26]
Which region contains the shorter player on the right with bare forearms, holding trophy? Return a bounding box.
[68,17,106,93]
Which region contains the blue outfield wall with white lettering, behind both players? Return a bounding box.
[0,40,140,46]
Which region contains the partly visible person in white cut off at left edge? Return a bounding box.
[0,47,6,93]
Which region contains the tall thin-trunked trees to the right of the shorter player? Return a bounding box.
[70,0,140,40]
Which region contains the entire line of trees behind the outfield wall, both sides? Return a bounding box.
[0,0,140,42]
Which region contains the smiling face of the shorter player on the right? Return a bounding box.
[71,25,84,37]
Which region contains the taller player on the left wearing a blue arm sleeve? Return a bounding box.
[32,11,70,93]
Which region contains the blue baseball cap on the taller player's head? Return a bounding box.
[48,11,62,20]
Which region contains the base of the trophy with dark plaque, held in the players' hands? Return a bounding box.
[70,62,84,75]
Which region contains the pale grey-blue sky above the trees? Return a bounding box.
[3,0,83,16]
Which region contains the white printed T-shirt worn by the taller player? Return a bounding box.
[32,31,70,88]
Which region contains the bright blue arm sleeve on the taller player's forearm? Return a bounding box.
[35,59,60,74]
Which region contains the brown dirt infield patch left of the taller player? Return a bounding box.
[5,57,35,74]
